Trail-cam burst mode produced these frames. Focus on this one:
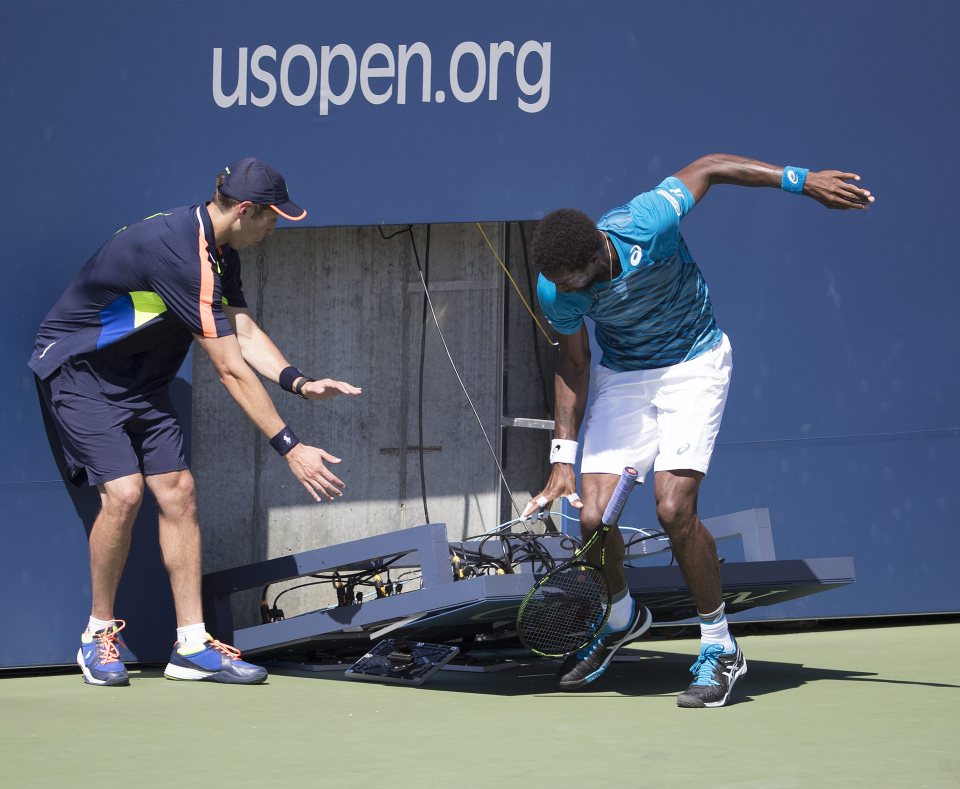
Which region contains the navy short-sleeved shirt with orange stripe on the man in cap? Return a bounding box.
[29,205,247,399]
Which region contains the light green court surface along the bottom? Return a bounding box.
[0,620,960,789]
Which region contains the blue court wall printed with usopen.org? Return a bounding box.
[0,0,960,665]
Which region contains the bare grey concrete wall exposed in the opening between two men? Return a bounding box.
[192,224,553,622]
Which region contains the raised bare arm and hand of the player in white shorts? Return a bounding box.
[675,153,874,210]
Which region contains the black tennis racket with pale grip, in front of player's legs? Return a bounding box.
[517,466,639,658]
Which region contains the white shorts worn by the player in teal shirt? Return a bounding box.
[580,335,733,482]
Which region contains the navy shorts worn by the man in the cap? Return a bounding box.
[38,373,188,485]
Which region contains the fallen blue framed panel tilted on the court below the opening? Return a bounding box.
[204,510,854,653]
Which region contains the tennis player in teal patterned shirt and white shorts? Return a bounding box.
[524,154,874,707]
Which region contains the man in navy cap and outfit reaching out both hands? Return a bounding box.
[29,158,361,685]
